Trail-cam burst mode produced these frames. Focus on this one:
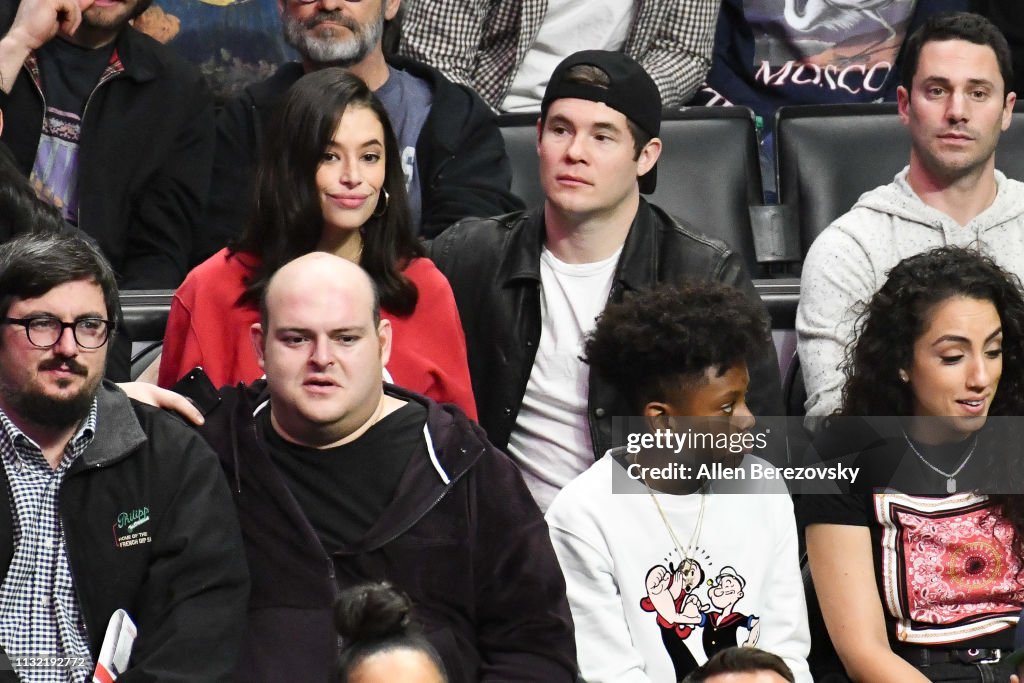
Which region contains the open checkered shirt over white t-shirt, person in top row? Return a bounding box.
[399,0,720,109]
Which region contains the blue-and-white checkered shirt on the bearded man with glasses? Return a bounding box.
[0,400,96,683]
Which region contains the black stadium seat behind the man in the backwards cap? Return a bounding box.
[499,106,762,275]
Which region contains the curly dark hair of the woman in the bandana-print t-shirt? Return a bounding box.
[838,247,1024,558]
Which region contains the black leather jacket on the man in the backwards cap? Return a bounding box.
[430,198,783,459]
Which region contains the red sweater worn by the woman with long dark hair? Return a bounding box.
[159,249,476,420]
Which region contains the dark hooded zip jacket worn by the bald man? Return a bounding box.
[202,380,577,683]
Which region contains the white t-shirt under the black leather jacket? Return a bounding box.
[508,248,622,510]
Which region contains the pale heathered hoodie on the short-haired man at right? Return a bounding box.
[797,168,1024,417]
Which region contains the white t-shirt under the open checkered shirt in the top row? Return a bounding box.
[499,0,636,112]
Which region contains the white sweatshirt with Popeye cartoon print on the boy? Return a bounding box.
[547,453,811,683]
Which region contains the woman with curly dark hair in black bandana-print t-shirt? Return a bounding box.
[800,247,1024,683]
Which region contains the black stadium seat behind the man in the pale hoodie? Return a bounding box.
[775,102,1024,254]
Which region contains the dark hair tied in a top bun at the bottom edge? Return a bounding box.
[334,583,447,683]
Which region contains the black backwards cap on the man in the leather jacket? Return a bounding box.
[541,50,662,195]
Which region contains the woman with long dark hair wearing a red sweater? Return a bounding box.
[159,69,476,419]
